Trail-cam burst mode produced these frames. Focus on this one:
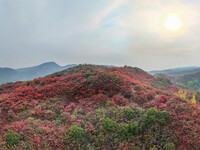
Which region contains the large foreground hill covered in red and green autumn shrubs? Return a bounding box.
[0,65,200,150]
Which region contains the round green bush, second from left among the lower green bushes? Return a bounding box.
[69,125,84,140]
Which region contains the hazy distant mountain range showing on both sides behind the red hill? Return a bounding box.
[0,62,200,90]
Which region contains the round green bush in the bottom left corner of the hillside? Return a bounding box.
[6,130,20,147]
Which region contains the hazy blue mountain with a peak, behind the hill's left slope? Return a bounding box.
[0,62,76,84]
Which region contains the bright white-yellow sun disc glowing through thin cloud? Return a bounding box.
[164,14,182,31]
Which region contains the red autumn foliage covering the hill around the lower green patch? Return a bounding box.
[0,67,200,149]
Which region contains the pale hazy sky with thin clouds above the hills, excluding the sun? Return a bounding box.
[0,0,200,70]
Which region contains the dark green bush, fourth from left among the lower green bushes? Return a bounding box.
[117,124,130,140]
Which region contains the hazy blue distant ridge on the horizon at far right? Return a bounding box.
[148,66,200,77]
